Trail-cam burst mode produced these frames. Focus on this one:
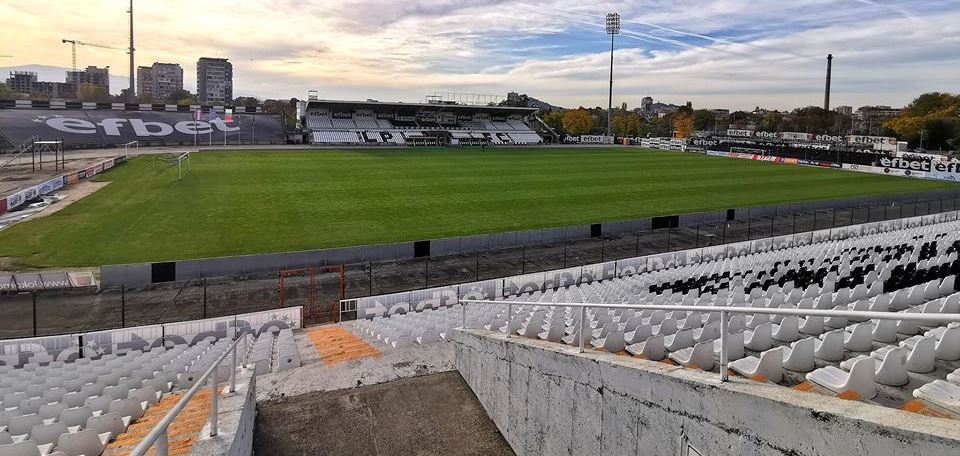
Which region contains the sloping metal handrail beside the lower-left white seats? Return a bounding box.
[130,332,247,456]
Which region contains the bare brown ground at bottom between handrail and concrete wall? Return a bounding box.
[253,371,514,456]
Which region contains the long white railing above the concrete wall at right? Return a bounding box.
[460,299,960,382]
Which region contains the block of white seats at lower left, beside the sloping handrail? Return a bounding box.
[0,306,301,456]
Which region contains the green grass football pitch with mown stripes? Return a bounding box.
[0,148,949,267]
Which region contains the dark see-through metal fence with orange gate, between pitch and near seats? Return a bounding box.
[0,194,960,338]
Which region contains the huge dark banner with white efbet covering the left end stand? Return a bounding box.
[0,109,286,148]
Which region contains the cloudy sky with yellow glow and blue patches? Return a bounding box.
[0,0,960,109]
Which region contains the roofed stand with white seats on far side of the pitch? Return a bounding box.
[300,100,543,145]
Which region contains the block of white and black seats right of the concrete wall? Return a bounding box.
[348,216,960,416]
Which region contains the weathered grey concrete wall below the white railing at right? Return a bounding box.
[454,331,960,456]
